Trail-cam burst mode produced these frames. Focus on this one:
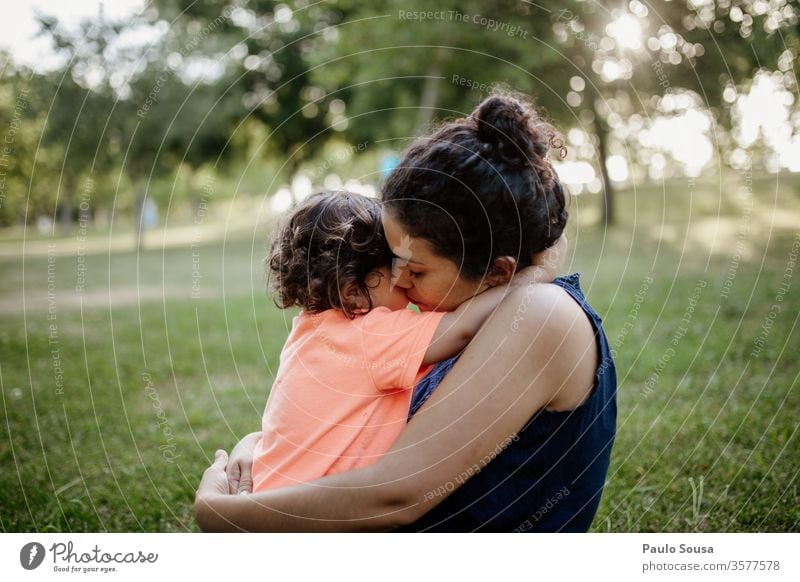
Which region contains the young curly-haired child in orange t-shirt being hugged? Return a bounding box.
[252,192,552,491]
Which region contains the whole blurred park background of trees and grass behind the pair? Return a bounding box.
[0,0,800,532]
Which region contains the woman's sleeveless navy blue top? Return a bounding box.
[400,273,617,532]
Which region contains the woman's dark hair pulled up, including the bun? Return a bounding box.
[382,93,567,280]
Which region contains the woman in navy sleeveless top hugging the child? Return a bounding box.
[195,95,616,531]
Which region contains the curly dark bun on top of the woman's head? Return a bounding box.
[471,95,566,180]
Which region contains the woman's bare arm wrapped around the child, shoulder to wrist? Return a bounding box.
[195,285,597,531]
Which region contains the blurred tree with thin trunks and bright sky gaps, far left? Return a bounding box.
[37,2,244,246]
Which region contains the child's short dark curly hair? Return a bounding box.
[266,192,392,318]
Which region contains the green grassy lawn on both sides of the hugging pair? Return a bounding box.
[0,171,800,532]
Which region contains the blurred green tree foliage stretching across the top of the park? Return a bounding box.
[0,0,800,226]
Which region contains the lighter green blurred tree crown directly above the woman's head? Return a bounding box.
[313,0,555,142]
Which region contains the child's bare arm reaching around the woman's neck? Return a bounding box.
[422,263,557,364]
